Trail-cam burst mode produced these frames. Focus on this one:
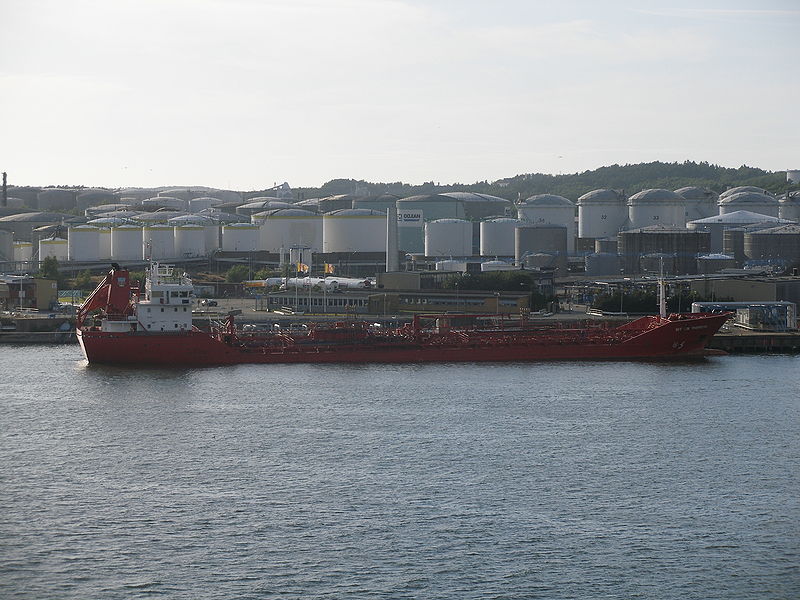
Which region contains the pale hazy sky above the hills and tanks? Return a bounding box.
[0,0,800,190]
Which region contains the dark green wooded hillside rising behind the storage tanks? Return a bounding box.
[294,161,786,201]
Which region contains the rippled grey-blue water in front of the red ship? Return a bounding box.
[0,346,800,599]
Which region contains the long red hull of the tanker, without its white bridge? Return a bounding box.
[78,314,729,366]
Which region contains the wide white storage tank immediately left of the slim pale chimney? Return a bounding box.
[322,208,386,252]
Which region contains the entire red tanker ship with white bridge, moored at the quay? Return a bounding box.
[77,264,730,366]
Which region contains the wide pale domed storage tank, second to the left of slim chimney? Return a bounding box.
[251,208,323,252]
